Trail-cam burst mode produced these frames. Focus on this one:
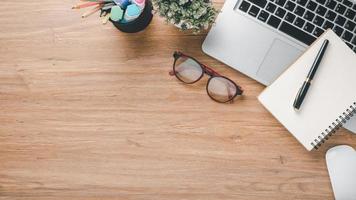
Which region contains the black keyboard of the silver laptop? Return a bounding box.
[238,0,356,52]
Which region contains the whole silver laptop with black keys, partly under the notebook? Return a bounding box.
[202,0,356,85]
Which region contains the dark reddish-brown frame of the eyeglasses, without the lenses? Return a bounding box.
[169,51,244,103]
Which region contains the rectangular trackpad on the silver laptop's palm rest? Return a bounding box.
[257,39,302,83]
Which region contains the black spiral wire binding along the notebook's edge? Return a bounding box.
[311,102,356,149]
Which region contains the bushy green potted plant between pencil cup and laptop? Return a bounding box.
[152,0,218,33]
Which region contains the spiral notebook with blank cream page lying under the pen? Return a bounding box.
[258,30,356,151]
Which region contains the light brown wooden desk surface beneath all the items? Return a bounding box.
[0,0,356,200]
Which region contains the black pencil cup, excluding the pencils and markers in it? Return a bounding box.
[110,0,153,33]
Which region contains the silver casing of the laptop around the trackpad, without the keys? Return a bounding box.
[202,0,307,85]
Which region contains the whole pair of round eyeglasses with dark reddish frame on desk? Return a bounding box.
[169,51,243,103]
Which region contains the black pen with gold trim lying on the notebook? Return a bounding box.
[293,40,329,110]
